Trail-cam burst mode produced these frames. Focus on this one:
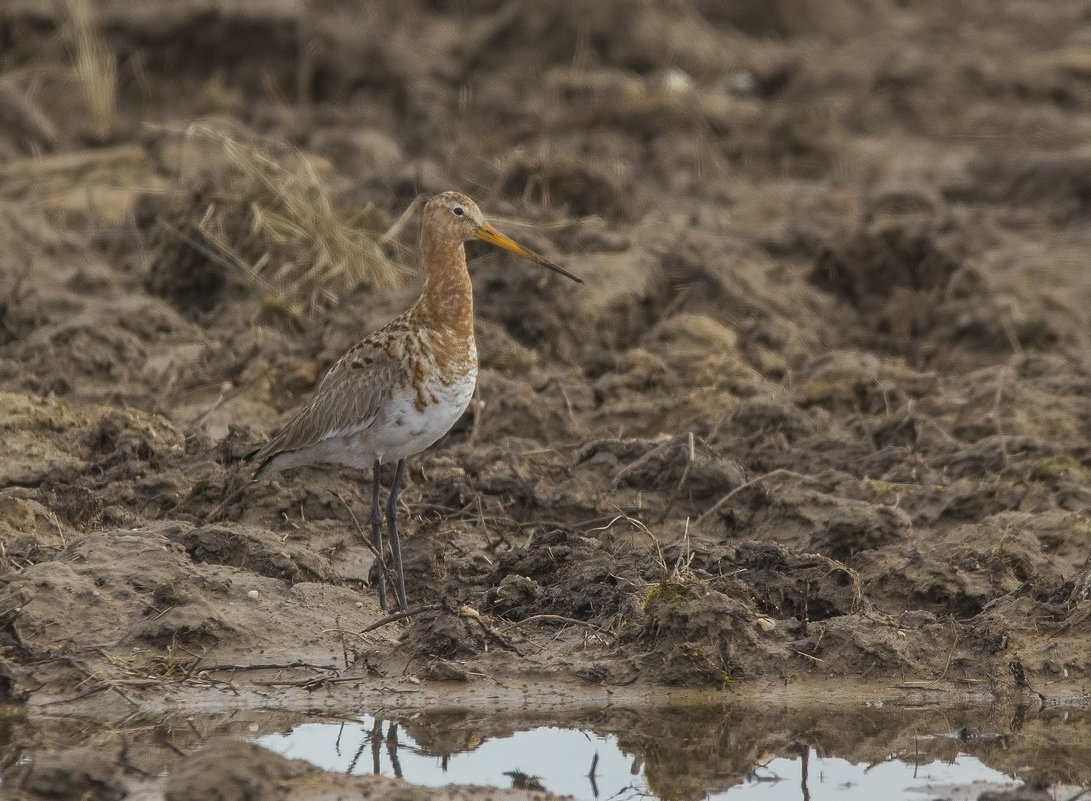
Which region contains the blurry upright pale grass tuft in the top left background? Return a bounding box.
[64,0,118,140]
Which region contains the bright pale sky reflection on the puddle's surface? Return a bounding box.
[256,715,1019,801]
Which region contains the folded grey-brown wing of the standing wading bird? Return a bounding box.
[251,340,405,477]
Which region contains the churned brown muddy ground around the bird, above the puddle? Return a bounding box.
[0,0,1091,798]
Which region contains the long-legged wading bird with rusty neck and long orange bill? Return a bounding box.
[252,192,580,610]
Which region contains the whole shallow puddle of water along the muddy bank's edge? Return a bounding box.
[0,700,1091,801]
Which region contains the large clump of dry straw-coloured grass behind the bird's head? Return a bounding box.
[154,123,401,318]
